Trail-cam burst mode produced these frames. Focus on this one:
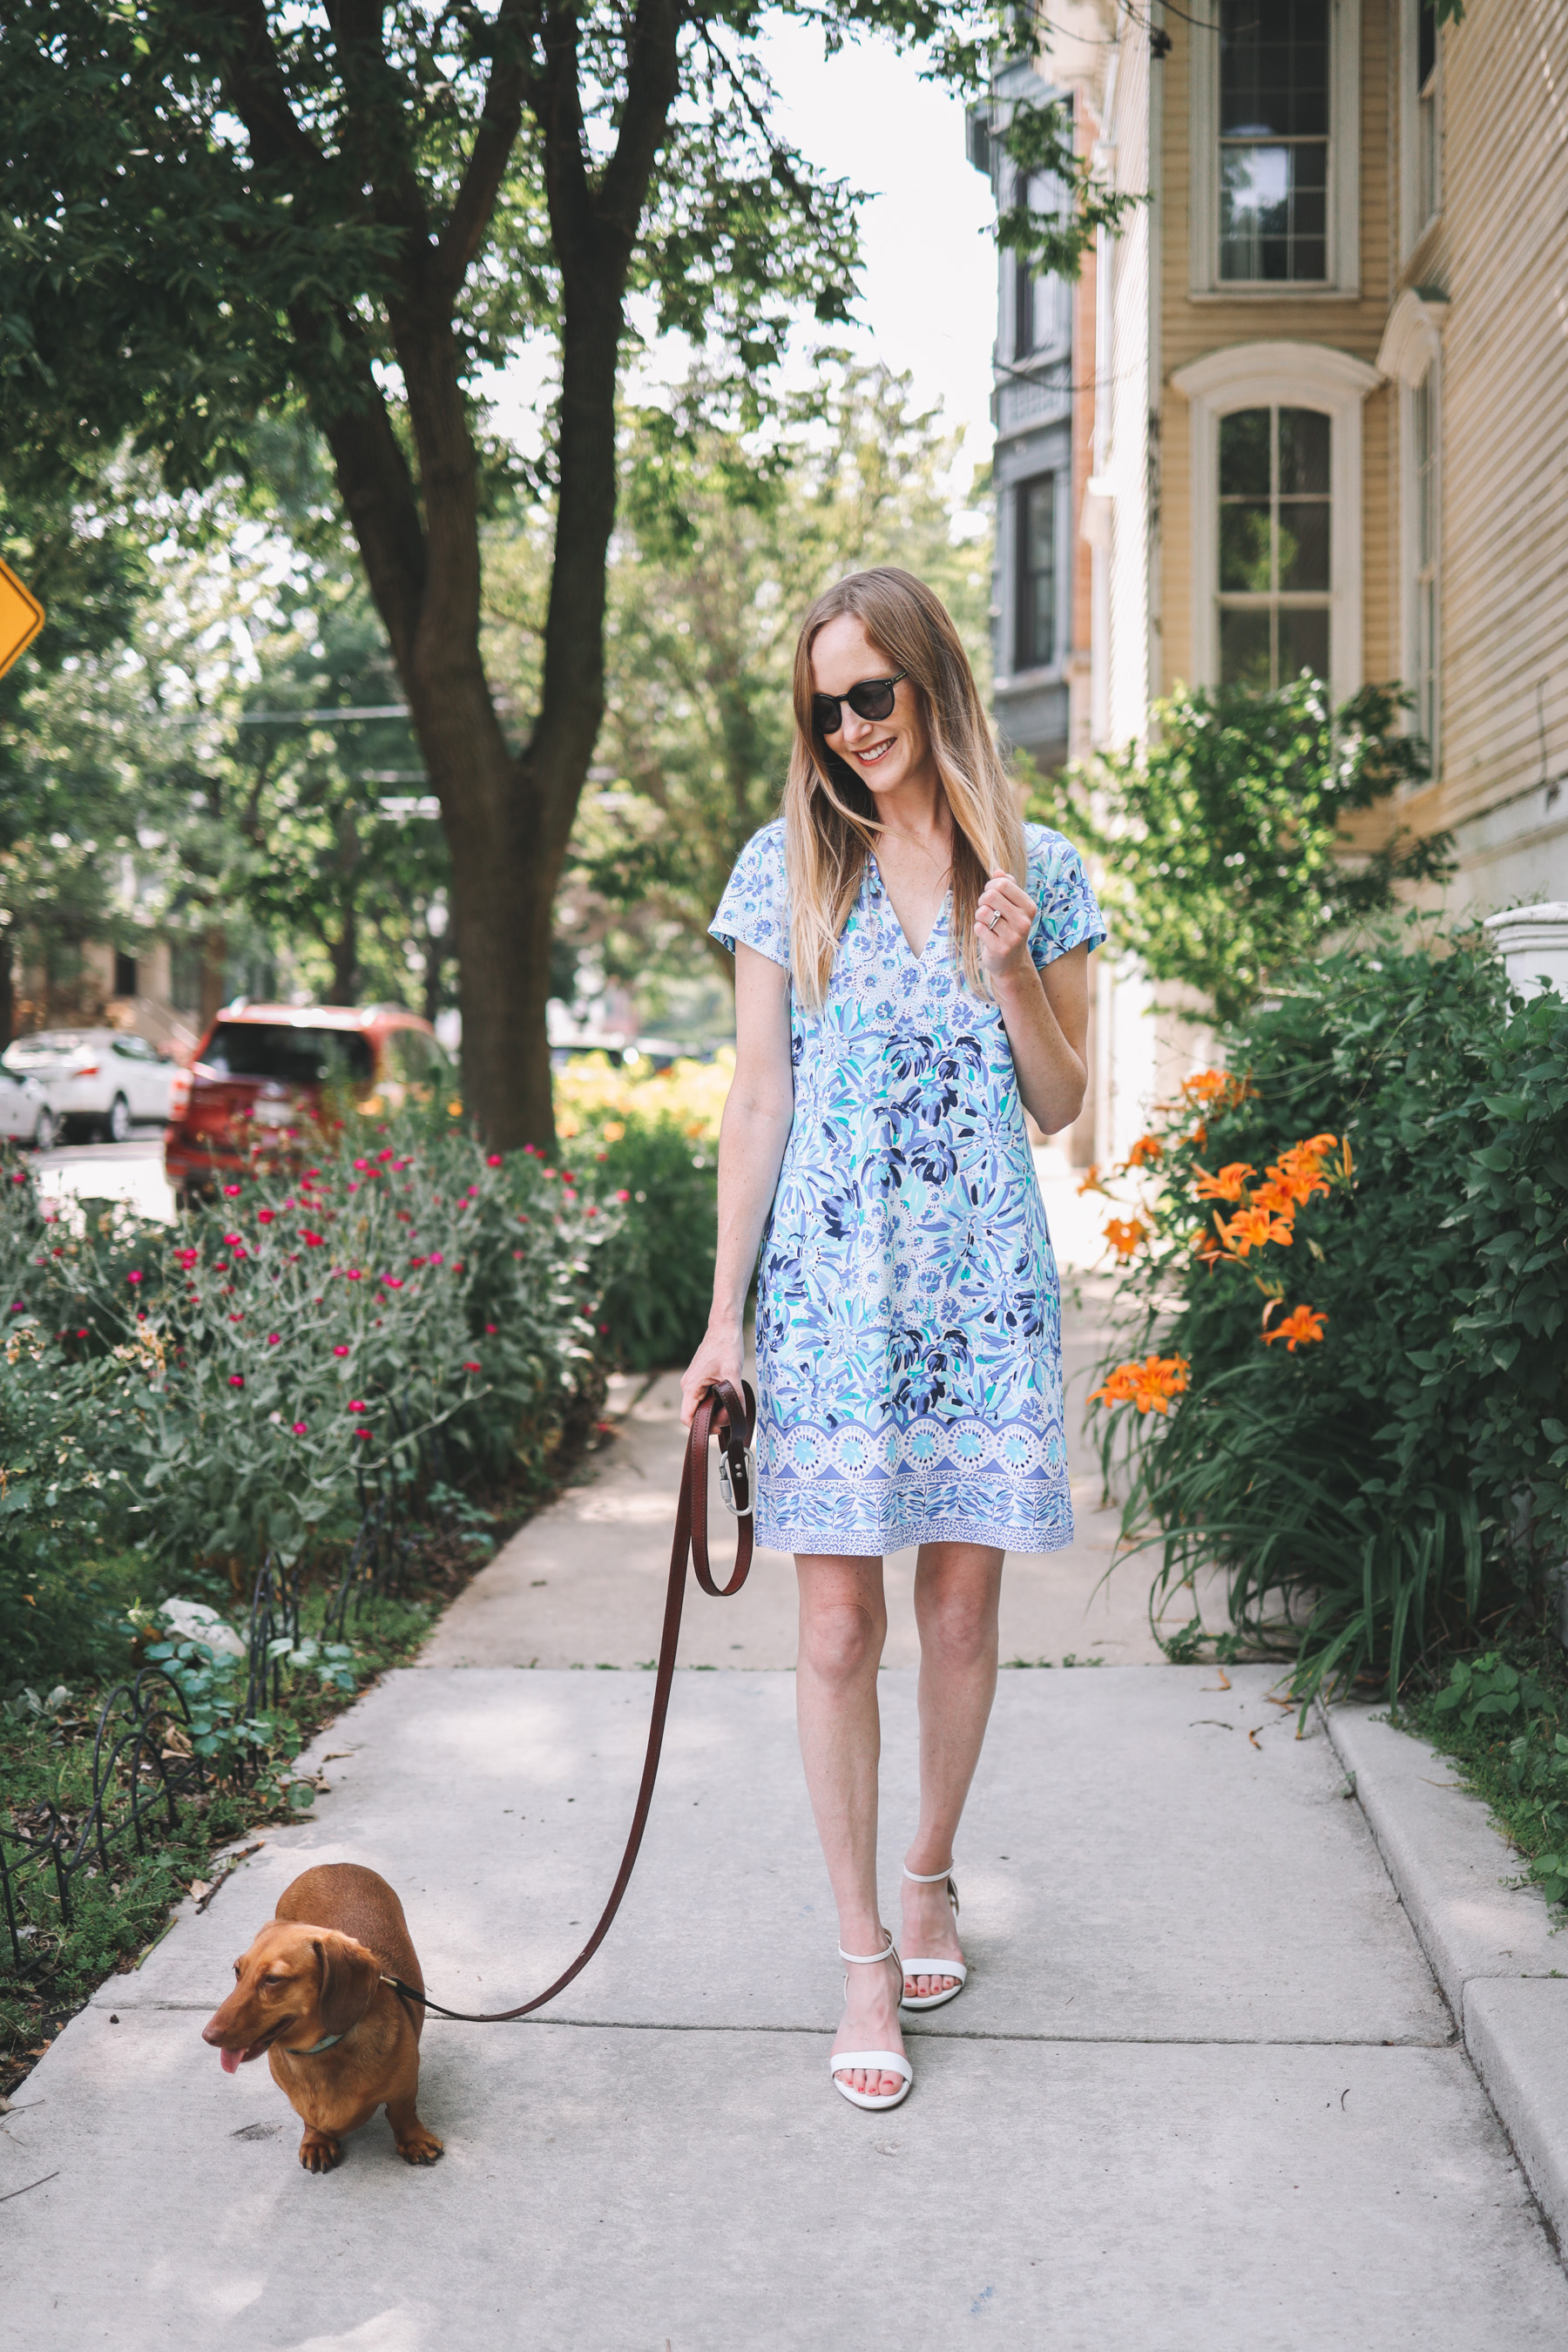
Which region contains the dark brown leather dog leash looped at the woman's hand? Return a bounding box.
[381,1381,757,2025]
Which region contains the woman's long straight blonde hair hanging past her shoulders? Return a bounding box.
[783,564,1025,1009]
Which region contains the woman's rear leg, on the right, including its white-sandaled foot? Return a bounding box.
[889,1543,1004,1997]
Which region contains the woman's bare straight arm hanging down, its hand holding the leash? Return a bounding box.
[682,945,794,1428]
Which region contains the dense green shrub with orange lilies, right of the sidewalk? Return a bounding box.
[1091,927,1568,1696]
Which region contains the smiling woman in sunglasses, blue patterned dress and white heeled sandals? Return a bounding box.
[682,567,1105,2107]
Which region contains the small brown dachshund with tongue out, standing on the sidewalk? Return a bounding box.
[202,1862,442,2173]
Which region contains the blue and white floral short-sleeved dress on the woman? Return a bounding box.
[710,823,1105,1555]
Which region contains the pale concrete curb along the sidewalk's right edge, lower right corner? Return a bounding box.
[1319,1706,1568,2248]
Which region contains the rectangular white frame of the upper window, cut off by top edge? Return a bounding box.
[1187,0,1362,303]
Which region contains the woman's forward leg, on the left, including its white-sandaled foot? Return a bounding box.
[794,1552,902,2096]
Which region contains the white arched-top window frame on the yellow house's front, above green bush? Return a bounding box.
[1171,343,1382,701]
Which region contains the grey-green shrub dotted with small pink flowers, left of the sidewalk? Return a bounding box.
[0,1125,618,1590]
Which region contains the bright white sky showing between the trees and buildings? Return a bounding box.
[491,19,997,483]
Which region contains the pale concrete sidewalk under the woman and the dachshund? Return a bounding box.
[0,1251,1568,2352]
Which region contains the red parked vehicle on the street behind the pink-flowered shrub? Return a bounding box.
[165,1002,456,1193]
